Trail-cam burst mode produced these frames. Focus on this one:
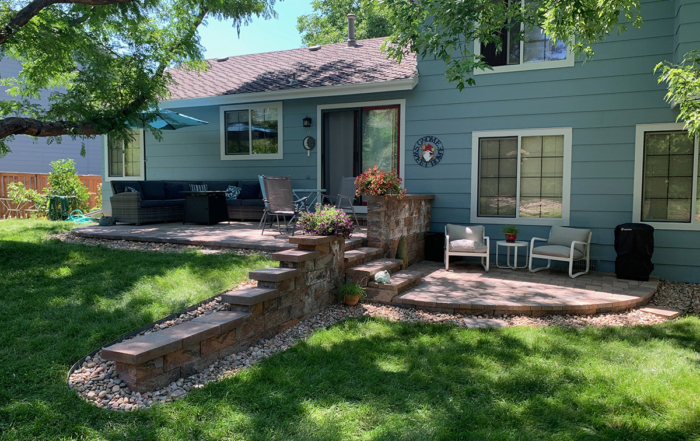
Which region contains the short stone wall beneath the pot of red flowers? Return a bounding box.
[364,194,435,265]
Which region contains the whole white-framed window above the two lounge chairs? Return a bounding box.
[471,128,572,225]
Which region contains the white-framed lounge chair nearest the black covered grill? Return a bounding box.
[529,227,593,279]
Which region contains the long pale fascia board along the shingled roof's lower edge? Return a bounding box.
[160,72,418,109]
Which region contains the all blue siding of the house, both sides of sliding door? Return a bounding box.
[104,0,700,282]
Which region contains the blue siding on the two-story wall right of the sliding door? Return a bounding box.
[406,0,700,282]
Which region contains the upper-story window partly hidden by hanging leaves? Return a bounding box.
[475,0,575,74]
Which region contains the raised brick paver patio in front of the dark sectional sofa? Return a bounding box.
[73,221,366,251]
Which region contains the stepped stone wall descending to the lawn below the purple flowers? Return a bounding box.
[101,236,345,392]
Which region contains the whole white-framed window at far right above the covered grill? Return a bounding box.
[634,123,700,230]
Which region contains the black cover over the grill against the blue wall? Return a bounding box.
[615,223,654,281]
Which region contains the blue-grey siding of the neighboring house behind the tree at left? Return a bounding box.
[0,58,102,175]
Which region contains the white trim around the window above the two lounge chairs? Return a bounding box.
[469,127,573,223]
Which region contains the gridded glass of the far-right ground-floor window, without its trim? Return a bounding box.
[642,132,698,223]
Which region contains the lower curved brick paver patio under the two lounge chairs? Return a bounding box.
[393,262,659,314]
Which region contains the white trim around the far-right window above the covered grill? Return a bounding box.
[632,123,700,231]
